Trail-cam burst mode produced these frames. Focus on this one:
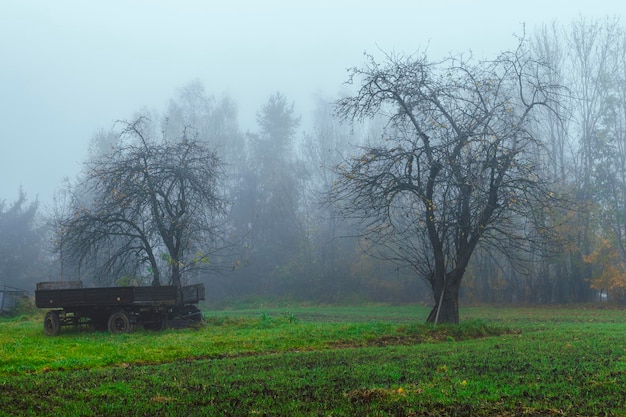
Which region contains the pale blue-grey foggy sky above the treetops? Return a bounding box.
[0,0,626,209]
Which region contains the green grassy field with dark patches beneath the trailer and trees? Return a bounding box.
[0,306,626,416]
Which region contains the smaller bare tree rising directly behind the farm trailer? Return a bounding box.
[57,118,226,298]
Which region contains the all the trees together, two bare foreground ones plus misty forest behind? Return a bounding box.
[0,18,626,322]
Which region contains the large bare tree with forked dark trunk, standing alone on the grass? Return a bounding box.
[330,43,557,323]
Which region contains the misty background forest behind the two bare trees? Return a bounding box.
[0,18,626,304]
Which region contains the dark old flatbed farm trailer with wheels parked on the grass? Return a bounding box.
[35,281,204,336]
